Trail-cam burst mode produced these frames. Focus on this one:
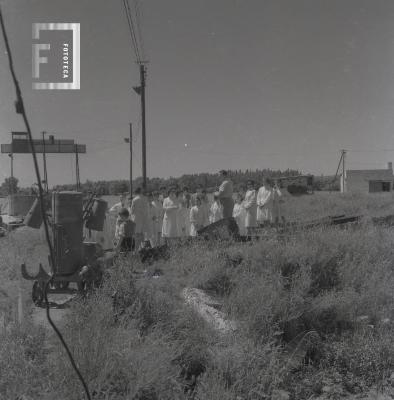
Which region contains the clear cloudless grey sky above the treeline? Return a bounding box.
[0,0,394,185]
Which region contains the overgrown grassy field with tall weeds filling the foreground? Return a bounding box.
[0,193,394,400]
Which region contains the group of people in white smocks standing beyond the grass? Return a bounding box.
[109,170,282,251]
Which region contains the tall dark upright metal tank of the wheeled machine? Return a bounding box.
[52,192,83,275]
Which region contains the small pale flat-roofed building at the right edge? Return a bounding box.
[341,162,394,193]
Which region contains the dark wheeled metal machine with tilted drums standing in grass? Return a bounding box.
[21,191,107,306]
